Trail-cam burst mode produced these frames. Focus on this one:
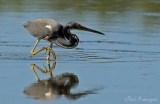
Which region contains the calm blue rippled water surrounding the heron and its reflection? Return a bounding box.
[0,0,160,104]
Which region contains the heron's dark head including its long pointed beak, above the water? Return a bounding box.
[66,22,105,35]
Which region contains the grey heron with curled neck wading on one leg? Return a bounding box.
[23,18,104,60]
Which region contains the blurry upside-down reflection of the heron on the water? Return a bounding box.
[24,62,98,101]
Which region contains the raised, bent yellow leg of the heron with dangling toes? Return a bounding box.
[31,39,56,60]
